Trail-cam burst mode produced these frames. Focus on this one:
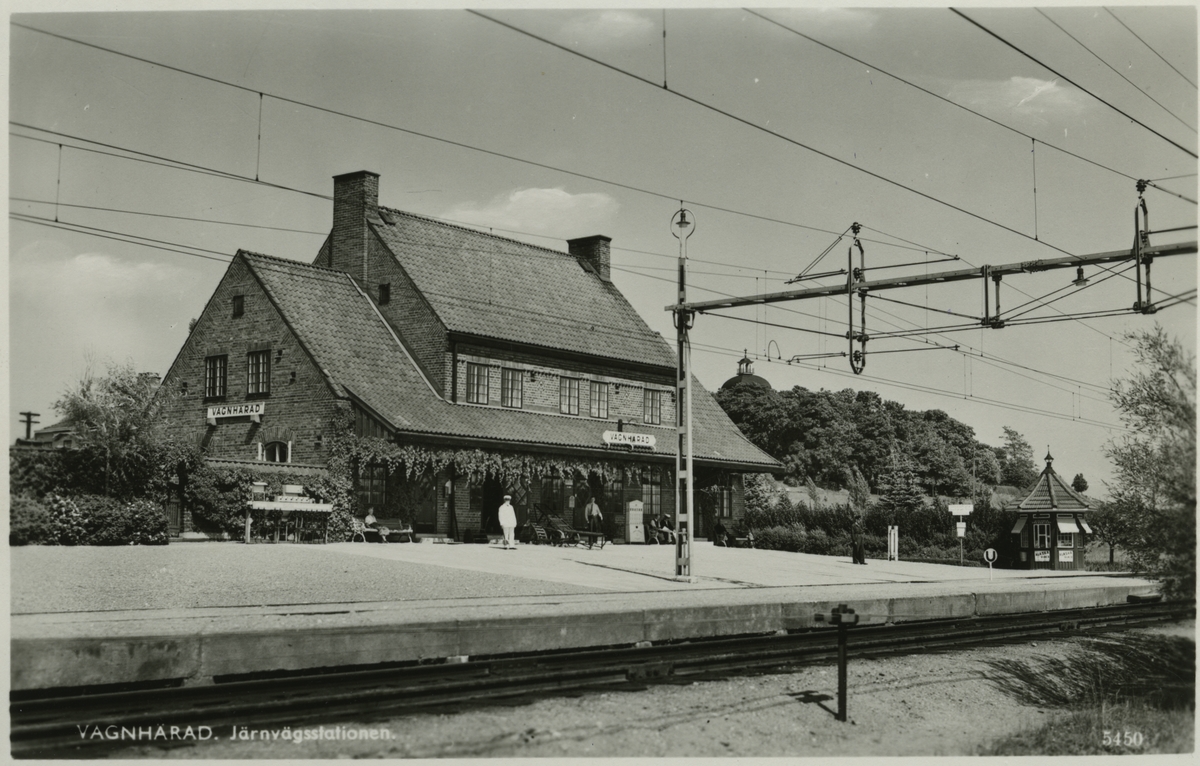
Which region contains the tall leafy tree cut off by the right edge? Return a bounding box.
[1105,325,1196,598]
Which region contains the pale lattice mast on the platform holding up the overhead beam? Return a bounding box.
[671,203,696,582]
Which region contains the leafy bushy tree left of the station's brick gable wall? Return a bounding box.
[54,364,175,499]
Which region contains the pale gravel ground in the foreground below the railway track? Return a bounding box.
[114,627,1161,759]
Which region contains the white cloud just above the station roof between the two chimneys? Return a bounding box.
[443,188,619,237]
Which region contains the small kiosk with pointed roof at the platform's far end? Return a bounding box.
[1006,450,1092,569]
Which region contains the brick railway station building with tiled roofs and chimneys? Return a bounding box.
[161,170,780,541]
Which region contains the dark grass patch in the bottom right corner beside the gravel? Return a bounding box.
[980,634,1195,755]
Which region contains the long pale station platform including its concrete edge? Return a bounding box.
[10,543,1157,690]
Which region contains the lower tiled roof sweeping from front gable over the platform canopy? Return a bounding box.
[239,251,778,471]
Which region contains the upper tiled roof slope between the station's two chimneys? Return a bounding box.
[373,208,674,367]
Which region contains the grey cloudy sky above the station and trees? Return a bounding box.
[6,6,1196,496]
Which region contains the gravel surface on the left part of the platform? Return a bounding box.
[8,543,596,615]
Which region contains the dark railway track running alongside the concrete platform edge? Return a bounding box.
[10,602,1195,758]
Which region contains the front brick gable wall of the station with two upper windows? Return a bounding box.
[162,259,337,463]
